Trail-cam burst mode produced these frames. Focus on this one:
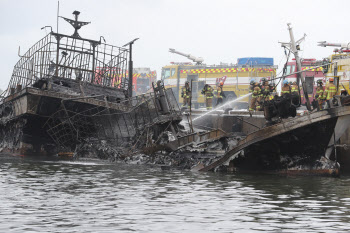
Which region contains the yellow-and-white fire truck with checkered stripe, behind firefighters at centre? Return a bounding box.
[161,58,277,108]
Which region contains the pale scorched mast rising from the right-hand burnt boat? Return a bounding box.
[280,23,311,111]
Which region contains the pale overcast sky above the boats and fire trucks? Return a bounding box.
[0,0,350,89]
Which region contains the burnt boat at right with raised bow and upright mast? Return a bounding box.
[199,24,350,176]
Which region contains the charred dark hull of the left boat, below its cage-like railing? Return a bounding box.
[0,83,182,156]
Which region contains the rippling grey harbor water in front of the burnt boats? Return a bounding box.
[0,155,350,232]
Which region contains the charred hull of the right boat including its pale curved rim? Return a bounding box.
[201,106,350,175]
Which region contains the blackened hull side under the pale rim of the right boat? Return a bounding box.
[231,118,339,174]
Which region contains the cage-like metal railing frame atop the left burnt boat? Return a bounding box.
[1,32,129,98]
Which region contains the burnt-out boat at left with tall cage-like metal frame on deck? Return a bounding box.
[0,11,185,155]
